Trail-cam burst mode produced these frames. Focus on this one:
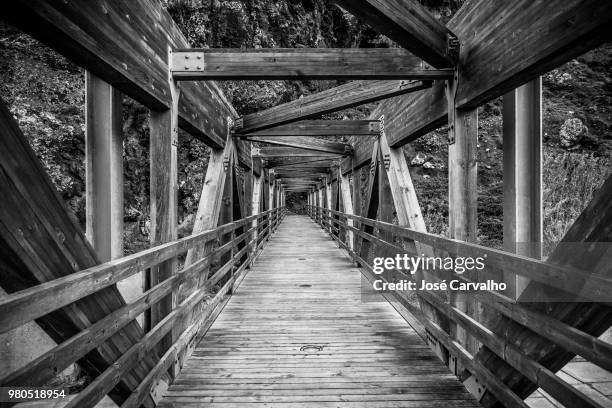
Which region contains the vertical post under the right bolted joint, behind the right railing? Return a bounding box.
[447,78,478,353]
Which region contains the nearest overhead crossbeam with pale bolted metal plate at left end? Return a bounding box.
[171,48,452,81]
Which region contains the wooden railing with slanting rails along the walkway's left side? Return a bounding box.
[0,208,284,408]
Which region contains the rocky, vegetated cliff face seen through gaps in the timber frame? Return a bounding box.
[0,0,612,251]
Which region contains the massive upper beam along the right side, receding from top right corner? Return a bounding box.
[343,0,612,171]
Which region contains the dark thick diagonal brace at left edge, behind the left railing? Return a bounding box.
[0,101,154,402]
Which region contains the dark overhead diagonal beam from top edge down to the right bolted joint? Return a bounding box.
[334,0,459,68]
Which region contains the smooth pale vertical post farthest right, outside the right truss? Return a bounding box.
[502,77,542,298]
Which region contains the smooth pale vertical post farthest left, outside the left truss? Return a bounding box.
[85,72,123,262]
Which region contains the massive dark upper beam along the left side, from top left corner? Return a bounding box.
[2,0,238,148]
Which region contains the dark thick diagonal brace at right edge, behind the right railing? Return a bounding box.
[476,176,612,406]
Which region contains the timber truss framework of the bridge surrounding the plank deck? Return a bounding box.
[0,0,612,407]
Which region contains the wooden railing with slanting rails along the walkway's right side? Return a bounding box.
[308,206,612,407]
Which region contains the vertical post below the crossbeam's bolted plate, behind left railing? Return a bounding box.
[149,51,180,355]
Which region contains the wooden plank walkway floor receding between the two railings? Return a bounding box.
[160,215,479,408]
